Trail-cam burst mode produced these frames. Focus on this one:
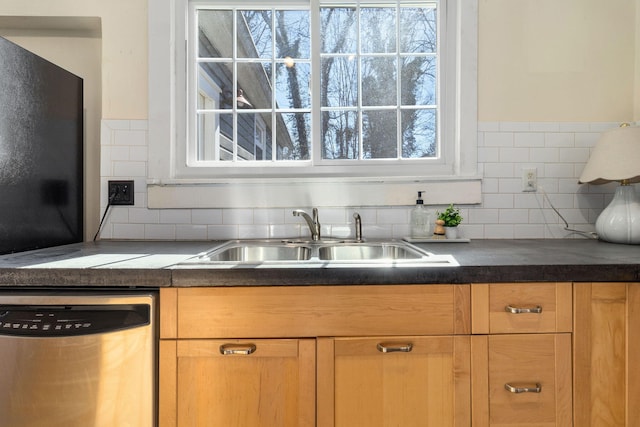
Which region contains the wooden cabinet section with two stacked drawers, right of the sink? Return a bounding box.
[471,283,573,427]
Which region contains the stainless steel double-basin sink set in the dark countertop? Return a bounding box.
[179,239,458,267]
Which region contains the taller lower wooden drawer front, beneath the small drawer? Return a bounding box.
[488,334,572,427]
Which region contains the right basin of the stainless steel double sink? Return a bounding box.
[318,243,428,261]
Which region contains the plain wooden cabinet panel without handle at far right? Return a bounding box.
[573,283,640,427]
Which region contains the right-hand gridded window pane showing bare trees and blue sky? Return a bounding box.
[320,2,439,160]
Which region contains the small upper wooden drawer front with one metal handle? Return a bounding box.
[471,283,573,334]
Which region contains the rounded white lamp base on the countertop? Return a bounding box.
[596,185,640,244]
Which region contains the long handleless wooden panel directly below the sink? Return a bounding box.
[174,285,470,338]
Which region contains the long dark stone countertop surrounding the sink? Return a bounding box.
[0,239,640,287]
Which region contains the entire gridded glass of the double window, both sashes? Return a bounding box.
[192,1,439,166]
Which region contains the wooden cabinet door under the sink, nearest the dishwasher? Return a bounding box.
[160,339,315,427]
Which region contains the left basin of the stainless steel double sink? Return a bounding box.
[199,241,311,263]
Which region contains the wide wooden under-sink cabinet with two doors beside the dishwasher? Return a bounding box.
[160,285,471,427]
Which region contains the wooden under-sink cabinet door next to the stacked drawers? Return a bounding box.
[318,336,471,427]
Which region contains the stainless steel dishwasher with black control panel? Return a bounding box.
[0,290,157,427]
